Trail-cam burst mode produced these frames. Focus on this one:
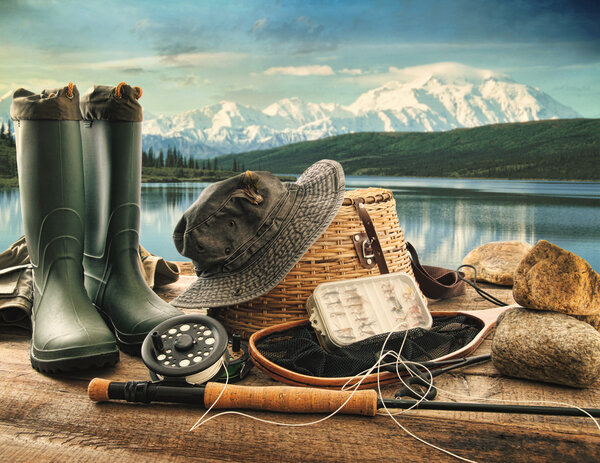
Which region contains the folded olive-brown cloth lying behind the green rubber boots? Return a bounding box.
[0,236,179,329]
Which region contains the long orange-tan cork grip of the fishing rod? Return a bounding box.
[204,383,377,416]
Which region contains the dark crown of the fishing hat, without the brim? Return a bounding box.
[173,171,289,275]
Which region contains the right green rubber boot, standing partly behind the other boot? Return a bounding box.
[81,84,181,355]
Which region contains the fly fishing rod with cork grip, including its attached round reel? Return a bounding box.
[88,315,600,417]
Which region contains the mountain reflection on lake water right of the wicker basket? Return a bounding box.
[392,188,600,269]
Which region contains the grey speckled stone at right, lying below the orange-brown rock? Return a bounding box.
[492,308,600,387]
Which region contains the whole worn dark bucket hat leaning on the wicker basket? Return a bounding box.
[171,160,345,308]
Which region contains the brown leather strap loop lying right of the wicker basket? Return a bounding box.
[406,242,466,299]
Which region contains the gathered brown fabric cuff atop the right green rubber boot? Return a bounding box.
[80,84,143,122]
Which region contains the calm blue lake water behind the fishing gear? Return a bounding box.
[0,177,600,271]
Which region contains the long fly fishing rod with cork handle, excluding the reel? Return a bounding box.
[88,378,600,418]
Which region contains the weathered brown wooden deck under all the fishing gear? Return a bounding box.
[0,270,600,463]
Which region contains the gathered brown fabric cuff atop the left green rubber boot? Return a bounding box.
[10,84,81,121]
